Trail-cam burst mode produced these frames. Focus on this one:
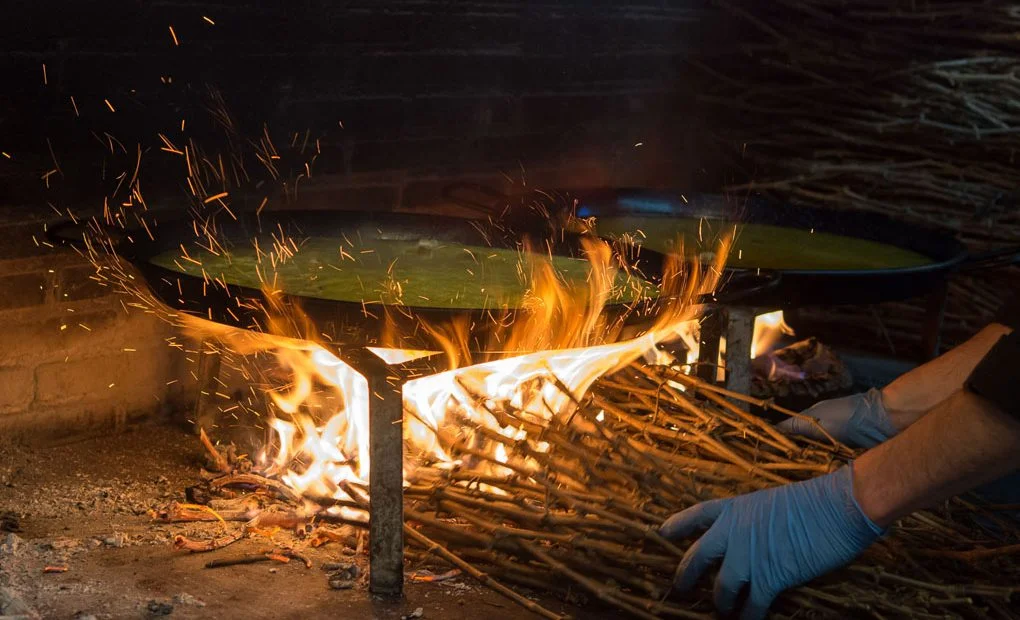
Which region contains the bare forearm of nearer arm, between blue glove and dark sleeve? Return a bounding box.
[854,389,1020,527]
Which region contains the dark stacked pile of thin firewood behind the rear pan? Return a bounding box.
[693,0,1020,351]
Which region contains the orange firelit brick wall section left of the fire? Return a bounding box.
[0,208,189,440]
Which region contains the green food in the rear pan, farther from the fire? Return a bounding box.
[596,215,932,270]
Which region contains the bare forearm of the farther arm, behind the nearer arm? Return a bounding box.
[882,323,1012,430]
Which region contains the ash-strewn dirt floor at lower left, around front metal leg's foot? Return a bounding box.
[0,425,599,620]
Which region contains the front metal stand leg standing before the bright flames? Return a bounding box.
[365,366,404,598]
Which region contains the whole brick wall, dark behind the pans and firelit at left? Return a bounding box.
[0,0,715,432]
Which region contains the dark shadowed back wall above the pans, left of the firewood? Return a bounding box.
[0,0,735,208]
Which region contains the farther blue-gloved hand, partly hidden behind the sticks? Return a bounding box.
[776,389,898,448]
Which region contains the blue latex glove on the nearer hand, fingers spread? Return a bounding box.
[659,467,883,620]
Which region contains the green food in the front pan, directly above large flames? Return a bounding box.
[151,237,655,309]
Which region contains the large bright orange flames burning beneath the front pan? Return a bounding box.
[179,232,728,510]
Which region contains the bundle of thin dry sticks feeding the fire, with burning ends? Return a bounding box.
[159,363,1020,619]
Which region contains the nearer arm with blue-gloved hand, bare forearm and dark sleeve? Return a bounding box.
[660,363,1020,620]
